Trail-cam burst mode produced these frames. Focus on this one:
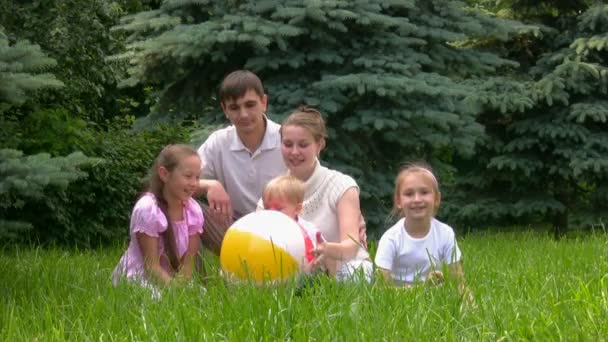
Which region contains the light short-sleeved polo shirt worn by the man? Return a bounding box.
[198,118,287,215]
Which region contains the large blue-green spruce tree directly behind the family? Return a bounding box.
[117,0,516,230]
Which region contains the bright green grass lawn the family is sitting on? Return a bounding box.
[0,233,608,341]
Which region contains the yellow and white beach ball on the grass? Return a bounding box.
[220,210,309,284]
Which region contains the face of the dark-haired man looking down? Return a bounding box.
[221,89,268,134]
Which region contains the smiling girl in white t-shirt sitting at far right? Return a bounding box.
[375,164,466,294]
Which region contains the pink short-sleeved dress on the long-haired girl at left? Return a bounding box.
[112,193,204,285]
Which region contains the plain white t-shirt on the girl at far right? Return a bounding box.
[375,218,461,284]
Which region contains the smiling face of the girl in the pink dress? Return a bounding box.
[158,155,201,202]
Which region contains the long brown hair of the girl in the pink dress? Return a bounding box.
[148,144,198,271]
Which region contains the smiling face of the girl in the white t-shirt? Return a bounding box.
[395,170,441,222]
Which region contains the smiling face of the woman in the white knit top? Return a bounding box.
[281,125,323,181]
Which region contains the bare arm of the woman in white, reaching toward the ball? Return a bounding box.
[318,188,361,260]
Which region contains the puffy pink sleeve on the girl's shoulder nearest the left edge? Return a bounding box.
[130,195,167,237]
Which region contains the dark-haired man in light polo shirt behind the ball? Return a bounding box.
[198,70,287,255]
